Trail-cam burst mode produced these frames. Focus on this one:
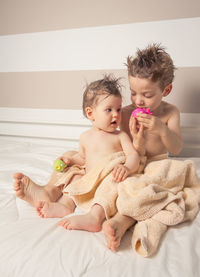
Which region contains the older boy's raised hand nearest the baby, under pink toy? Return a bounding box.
[129,116,146,155]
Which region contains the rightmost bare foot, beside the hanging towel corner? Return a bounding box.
[103,213,135,251]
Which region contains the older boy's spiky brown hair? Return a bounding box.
[126,44,176,90]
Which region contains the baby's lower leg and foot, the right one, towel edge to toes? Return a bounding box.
[58,204,105,232]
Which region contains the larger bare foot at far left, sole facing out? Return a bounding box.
[13,173,50,206]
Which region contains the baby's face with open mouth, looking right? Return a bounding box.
[90,95,122,132]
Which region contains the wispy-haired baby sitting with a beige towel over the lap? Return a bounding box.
[14,76,139,232]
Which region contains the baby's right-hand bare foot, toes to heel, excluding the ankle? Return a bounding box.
[58,214,102,232]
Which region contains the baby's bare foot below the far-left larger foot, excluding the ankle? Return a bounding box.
[36,201,73,218]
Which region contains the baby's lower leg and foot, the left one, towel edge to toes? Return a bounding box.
[36,194,76,218]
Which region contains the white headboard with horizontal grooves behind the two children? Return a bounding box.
[0,108,200,157]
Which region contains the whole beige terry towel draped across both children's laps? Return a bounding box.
[53,152,200,257]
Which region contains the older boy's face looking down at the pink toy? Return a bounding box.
[129,76,165,111]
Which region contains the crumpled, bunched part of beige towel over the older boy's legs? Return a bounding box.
[117,156,200,257]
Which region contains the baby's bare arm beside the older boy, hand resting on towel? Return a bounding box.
[113,132,139,182]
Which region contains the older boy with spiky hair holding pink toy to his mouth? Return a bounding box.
[103,44,182,251]
